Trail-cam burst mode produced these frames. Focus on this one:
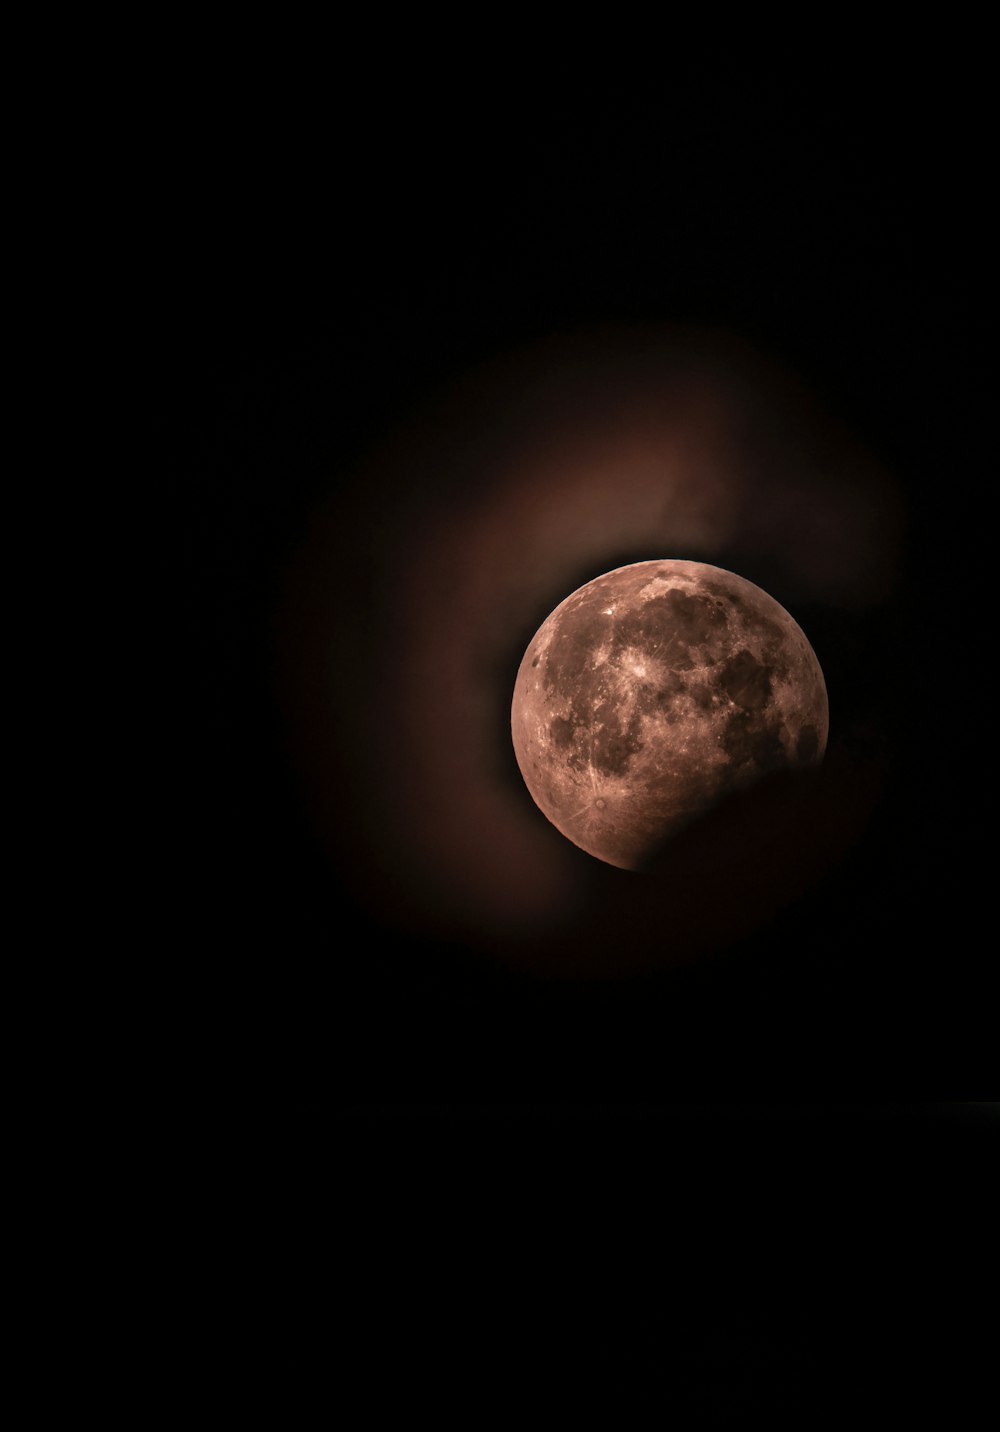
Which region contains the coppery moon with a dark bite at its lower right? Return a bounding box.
[511,560,830,871]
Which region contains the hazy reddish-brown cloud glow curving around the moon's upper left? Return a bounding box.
[278,329,903,973]
